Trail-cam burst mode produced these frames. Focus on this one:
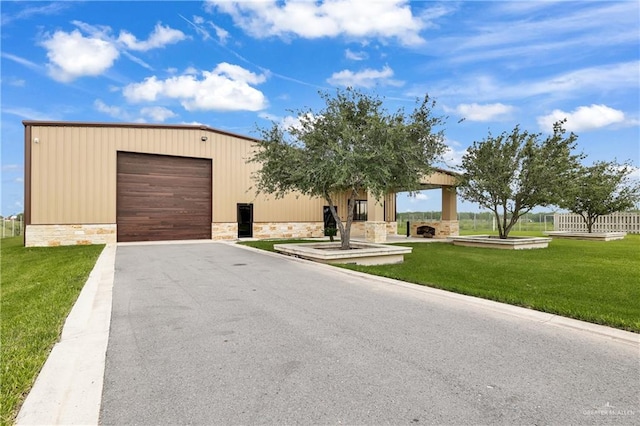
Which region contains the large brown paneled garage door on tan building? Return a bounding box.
[117,152,212,241]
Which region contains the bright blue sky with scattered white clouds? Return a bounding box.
[0,0,640,215]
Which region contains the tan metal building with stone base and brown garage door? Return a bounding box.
[23,121,457,246]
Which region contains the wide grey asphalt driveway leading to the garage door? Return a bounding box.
[100,243,640,425]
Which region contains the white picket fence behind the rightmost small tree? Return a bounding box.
[553,213,640,234]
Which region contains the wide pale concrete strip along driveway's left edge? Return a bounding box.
[16,244,116,425]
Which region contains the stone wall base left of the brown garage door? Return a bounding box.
[24,224,117,247]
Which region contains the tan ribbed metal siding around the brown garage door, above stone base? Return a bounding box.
[28,123,336,224]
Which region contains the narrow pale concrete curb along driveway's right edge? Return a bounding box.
[227,243,640,349]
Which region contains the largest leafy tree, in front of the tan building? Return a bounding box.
[249,88,446,250]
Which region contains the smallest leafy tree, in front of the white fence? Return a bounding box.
[559,161,640,233]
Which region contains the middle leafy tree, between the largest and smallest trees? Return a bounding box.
[459,121,583,239]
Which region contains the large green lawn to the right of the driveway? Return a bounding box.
[241,236,640,332]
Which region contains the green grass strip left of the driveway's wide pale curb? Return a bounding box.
[0,237,104,425]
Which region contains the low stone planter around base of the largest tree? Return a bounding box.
[273,242,412,265]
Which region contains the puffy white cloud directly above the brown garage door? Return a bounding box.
[123,62,267,111]
